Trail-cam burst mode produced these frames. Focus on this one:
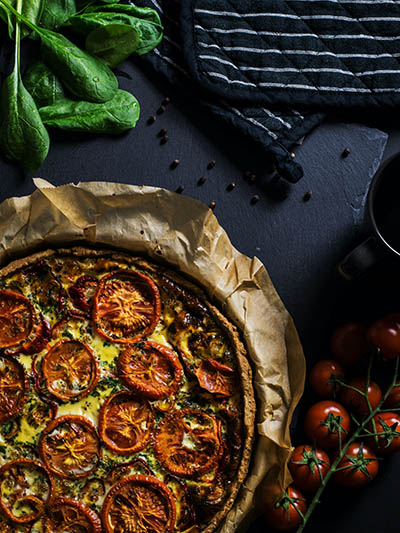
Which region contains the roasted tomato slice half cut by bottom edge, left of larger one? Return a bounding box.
[43,498,101,533]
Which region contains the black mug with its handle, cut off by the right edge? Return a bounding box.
[338,154,400,280]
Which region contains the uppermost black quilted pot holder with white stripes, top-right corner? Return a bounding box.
[183,0,400,110]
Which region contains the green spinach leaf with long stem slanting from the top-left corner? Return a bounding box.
[0,0,118,102]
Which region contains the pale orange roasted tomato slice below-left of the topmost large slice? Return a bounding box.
[42,340,99,401]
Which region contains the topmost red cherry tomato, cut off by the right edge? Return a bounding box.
[368,313,400,359]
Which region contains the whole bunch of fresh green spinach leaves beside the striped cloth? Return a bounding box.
[0,0,163,171]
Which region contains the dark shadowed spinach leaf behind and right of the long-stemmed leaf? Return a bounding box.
[86,24,140,68]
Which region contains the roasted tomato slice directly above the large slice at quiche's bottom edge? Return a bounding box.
[99,391,153,455]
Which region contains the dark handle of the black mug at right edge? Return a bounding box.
[337,237,384,281]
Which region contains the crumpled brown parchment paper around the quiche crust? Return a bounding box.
[0,178,305,533]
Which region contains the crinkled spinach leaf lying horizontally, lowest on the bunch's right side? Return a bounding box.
[39,90,140,134]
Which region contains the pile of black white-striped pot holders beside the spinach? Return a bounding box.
[136,0,400,182]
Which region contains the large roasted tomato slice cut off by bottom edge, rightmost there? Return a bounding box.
[101,475,175,533]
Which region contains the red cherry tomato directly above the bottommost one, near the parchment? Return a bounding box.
[288,444,331,492]
